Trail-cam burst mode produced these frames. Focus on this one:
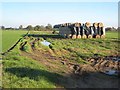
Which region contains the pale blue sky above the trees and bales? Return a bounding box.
[1,2,118,27]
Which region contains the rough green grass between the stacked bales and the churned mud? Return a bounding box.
[47,32,119,62]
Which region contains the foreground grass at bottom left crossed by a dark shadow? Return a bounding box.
[2,52,61,88]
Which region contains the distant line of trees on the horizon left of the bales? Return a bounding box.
[0,24,53,31]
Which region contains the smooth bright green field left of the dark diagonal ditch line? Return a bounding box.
[1,30,27,52]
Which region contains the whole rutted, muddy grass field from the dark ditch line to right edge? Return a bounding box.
[2,31,120,88]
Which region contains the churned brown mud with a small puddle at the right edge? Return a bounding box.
[87,56,120,76]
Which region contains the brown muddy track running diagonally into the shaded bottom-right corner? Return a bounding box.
[22,47,118,88]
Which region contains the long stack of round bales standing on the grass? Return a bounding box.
[54,22,105,39]
